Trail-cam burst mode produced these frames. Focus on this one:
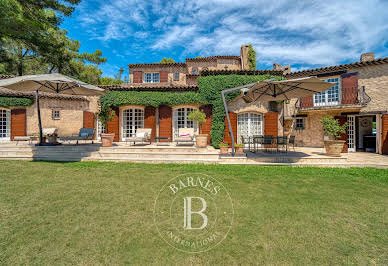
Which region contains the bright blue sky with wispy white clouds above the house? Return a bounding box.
[62,0,388,76]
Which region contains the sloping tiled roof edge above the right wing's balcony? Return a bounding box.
[286,57,388,78]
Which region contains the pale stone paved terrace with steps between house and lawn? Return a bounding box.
[0,142,388,168]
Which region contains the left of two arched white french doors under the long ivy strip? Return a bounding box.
[122,108,144,140]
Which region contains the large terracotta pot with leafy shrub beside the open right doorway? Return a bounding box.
[321,116,346,157]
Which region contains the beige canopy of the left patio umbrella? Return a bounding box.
[0,73,105,96]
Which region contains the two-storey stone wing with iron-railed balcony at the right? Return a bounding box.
[282,53,388,154]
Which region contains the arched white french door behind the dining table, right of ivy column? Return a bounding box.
[237,113,263,143]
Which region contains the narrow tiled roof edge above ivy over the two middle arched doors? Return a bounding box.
[99,83,198,92]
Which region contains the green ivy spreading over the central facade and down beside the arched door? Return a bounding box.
[100,75,282,148]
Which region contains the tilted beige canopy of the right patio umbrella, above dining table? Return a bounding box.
[244,77,333,102]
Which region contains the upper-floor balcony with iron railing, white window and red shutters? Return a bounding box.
[295,87,371,110]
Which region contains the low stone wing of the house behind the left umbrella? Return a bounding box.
[0,75,98,141]
